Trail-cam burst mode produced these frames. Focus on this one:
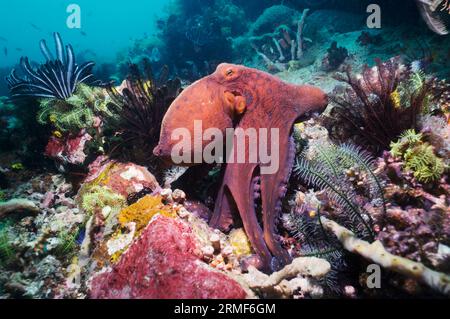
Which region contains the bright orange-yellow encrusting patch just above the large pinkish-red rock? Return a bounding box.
[118,195,177,233]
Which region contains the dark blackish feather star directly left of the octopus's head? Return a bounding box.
[106,60,181,166]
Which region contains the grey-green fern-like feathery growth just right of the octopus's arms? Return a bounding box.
[294,145,385,239]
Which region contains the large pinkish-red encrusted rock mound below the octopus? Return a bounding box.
[91,216,247,299]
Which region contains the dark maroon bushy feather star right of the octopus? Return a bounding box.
[325,59,434,152]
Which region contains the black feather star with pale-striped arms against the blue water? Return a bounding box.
[6,32,95,100]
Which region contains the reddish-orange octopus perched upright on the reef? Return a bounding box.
[154,64,328,272]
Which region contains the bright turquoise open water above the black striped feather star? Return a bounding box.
[0,0,172,67]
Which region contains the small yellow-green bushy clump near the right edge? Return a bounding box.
[391,130,446,183]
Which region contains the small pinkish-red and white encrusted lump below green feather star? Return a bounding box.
[45,132,92,165]
